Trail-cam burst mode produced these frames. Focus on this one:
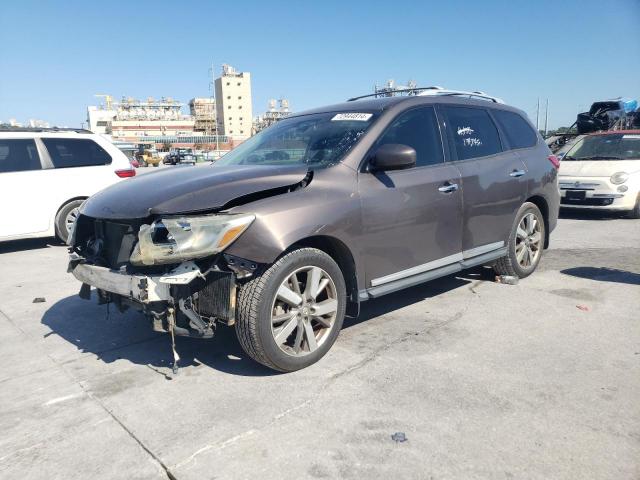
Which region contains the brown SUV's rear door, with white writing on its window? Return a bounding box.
[440,105,528,253]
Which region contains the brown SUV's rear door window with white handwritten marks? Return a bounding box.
[444,107,502,160]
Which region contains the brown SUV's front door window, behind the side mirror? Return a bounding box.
[376,107,444,167]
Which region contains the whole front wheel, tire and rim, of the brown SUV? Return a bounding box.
[236,248,346,372]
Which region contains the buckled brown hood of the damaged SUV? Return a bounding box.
[81,165,308,220]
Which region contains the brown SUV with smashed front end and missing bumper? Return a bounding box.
[69,90,559,371]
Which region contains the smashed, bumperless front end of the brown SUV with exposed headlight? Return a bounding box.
[68,213,258,346]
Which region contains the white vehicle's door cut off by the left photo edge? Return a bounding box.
[0,138,49,238]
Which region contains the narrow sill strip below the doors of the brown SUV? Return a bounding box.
[358,247,507,301]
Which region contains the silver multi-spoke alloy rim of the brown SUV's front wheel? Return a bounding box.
[271,266,338,356]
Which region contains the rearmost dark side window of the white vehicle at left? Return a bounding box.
[42,138,111,168]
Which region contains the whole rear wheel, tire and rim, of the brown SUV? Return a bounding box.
[493,202,545,278]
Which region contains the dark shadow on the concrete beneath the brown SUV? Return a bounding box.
[41,273,472,380]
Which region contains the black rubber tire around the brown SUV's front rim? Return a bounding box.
[236,248,347,372]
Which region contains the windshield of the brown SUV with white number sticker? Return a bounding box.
[215,112,377,168]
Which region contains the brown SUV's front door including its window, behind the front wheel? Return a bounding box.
[359,106,462,288]
